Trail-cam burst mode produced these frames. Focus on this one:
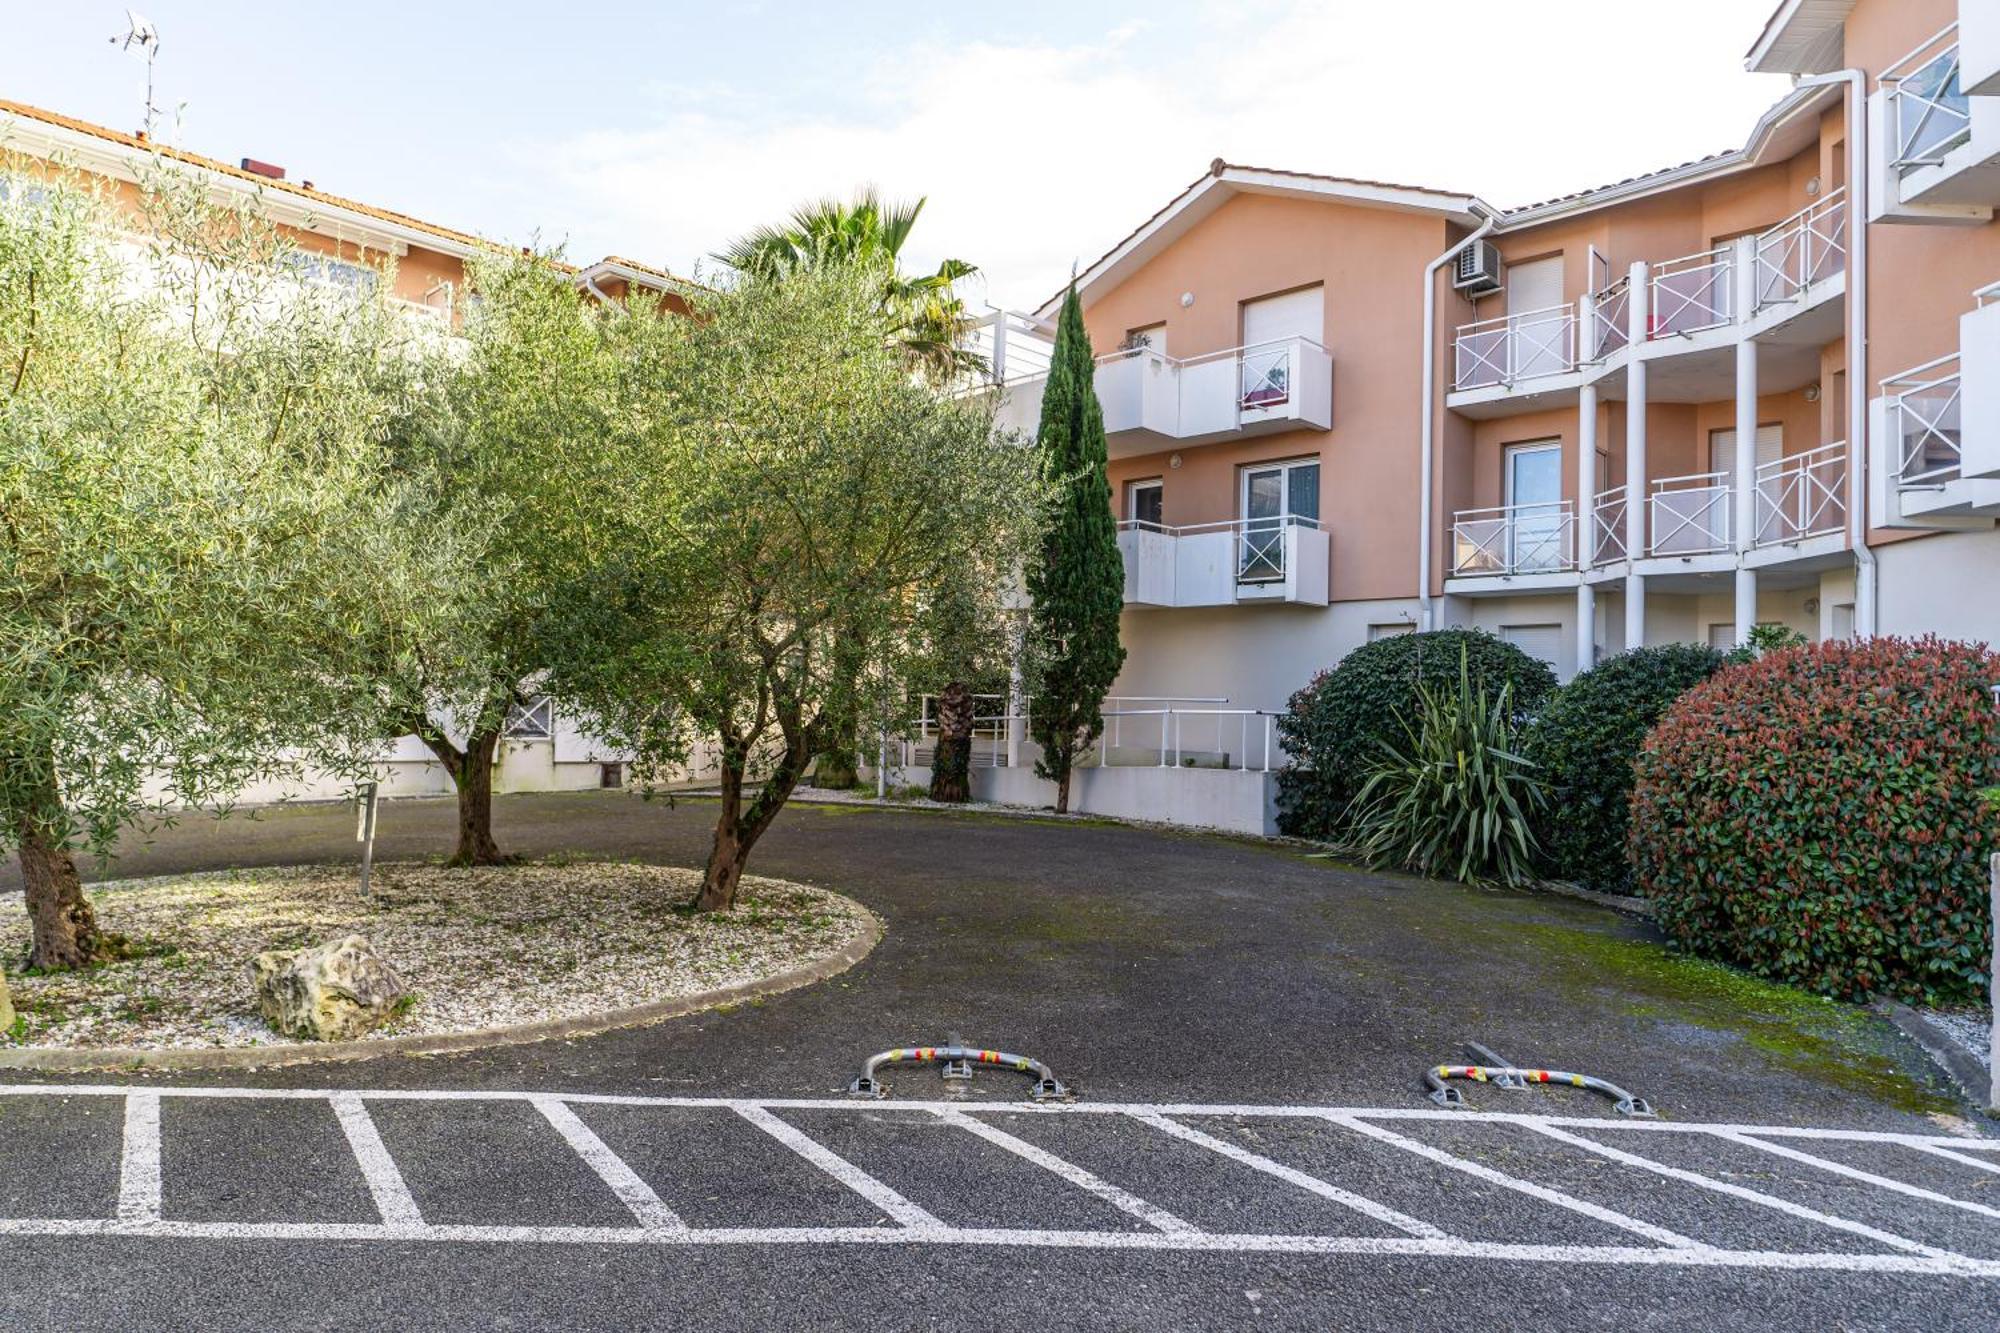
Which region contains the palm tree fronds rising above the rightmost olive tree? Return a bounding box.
[714,186,984,382]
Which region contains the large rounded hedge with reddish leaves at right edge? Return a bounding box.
[1630,638,2000,1001]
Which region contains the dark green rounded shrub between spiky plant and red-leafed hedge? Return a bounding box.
[1528,642,1724,893]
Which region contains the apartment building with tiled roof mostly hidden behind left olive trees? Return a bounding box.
[0,100,688,801]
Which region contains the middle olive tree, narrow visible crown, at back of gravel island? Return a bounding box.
[374,254,616,865]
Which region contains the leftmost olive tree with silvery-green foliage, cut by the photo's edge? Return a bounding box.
[0,162,418,969]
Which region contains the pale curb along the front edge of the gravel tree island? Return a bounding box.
[0,907,882,1073]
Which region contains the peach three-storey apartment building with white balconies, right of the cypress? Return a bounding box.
[986,0,2000,728]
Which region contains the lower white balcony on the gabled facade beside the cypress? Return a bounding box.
[1118,516,1328,606]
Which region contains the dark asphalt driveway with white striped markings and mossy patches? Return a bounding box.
[0,795,2000,1329]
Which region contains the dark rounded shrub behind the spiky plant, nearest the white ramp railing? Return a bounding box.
[1278,628,1556,839]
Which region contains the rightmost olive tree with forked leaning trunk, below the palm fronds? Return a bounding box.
[556,266,1036,911]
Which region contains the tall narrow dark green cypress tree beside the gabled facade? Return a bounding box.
[1024,280,1124,813]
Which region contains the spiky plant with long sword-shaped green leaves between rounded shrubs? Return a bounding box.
[1348,650,1542,885]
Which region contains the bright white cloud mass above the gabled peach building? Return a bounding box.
[544,0,1784,306]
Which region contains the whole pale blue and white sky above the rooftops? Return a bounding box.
[0,0,1786,308]
